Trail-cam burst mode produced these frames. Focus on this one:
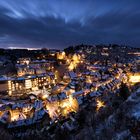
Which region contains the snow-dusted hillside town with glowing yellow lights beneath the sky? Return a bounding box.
[0,44,140,140]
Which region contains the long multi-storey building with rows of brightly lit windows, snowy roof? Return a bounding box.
[0,72,56,95]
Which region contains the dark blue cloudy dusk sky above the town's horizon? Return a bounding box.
[0,0,140,48]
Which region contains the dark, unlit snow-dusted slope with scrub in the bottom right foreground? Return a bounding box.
[73,88,140,140]
